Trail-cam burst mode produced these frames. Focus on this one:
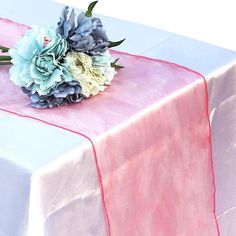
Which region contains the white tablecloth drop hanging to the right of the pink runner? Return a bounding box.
[209,63,236,236]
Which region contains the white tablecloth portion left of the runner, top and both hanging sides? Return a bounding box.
[0,112,105,236]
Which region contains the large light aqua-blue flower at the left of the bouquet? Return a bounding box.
[9,27,73,95]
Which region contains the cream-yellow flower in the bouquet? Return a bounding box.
[65,52,115,98]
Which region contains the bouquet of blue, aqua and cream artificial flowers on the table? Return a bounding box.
[0,1,124,108]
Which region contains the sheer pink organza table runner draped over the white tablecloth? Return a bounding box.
[0,20,219,236]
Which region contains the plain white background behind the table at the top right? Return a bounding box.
[54,0,236,51]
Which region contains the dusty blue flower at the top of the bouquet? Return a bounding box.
[57,6,109,55]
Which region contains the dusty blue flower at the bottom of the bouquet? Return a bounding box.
[22,81,83,108]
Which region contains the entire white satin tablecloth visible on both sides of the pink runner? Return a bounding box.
[0,0,236,236]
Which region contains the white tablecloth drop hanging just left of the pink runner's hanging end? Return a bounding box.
[28,143,106,236]
